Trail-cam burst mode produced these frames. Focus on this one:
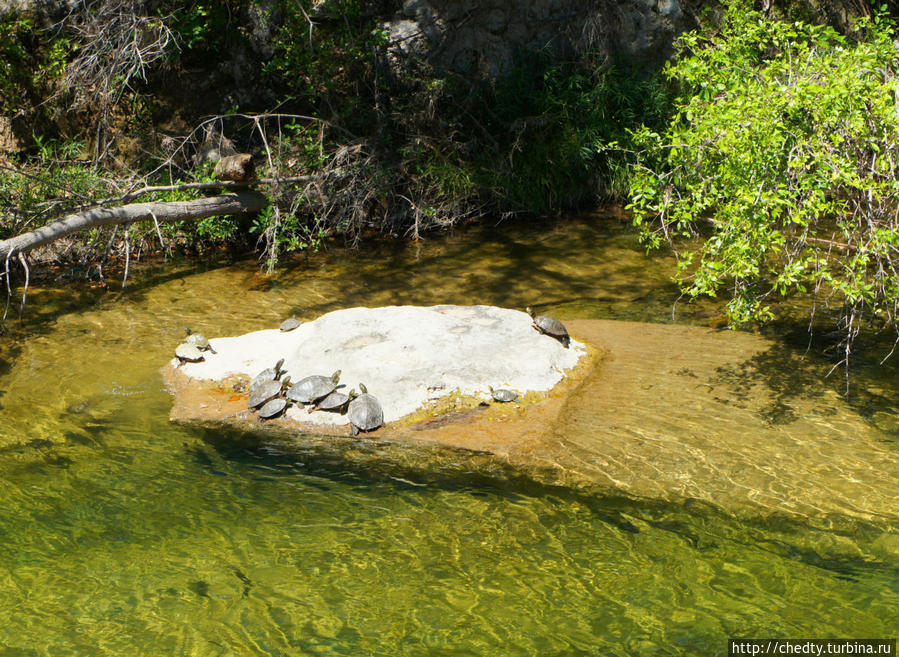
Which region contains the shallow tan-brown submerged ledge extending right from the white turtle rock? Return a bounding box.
[166,320,899,522]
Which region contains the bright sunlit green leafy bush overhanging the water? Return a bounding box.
[630,0,899,354]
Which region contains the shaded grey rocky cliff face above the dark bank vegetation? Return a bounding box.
[385,0,687,77]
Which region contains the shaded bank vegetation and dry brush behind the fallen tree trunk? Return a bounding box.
[0,0,670,276]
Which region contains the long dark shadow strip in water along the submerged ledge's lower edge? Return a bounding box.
[189,422,899,582]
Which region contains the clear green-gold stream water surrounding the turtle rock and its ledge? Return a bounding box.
[0,214,899,657]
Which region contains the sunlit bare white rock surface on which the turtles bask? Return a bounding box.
[180,306,585,424]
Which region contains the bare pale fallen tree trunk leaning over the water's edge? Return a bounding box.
[0,190,267,264]
